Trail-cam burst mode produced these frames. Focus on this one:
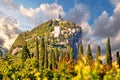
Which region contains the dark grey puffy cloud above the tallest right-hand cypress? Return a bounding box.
[94,9,120,37]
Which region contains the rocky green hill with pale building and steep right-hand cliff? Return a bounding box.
[11,20,82,58]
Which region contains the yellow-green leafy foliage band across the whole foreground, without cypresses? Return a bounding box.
[0,53,120,80]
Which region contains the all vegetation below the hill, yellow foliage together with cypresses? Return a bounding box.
[0,39,120,80]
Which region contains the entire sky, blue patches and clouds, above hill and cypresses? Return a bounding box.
[0,0,120,51]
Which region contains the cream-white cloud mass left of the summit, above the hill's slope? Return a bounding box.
[0,0,65,49]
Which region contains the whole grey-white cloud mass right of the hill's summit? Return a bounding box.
[67,0,120,53]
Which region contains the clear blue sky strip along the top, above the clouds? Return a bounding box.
[13,0,114,24]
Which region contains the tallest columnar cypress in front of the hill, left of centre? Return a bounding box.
[40,37,45,69]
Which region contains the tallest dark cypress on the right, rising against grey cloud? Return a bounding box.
[106,38,112,65]
